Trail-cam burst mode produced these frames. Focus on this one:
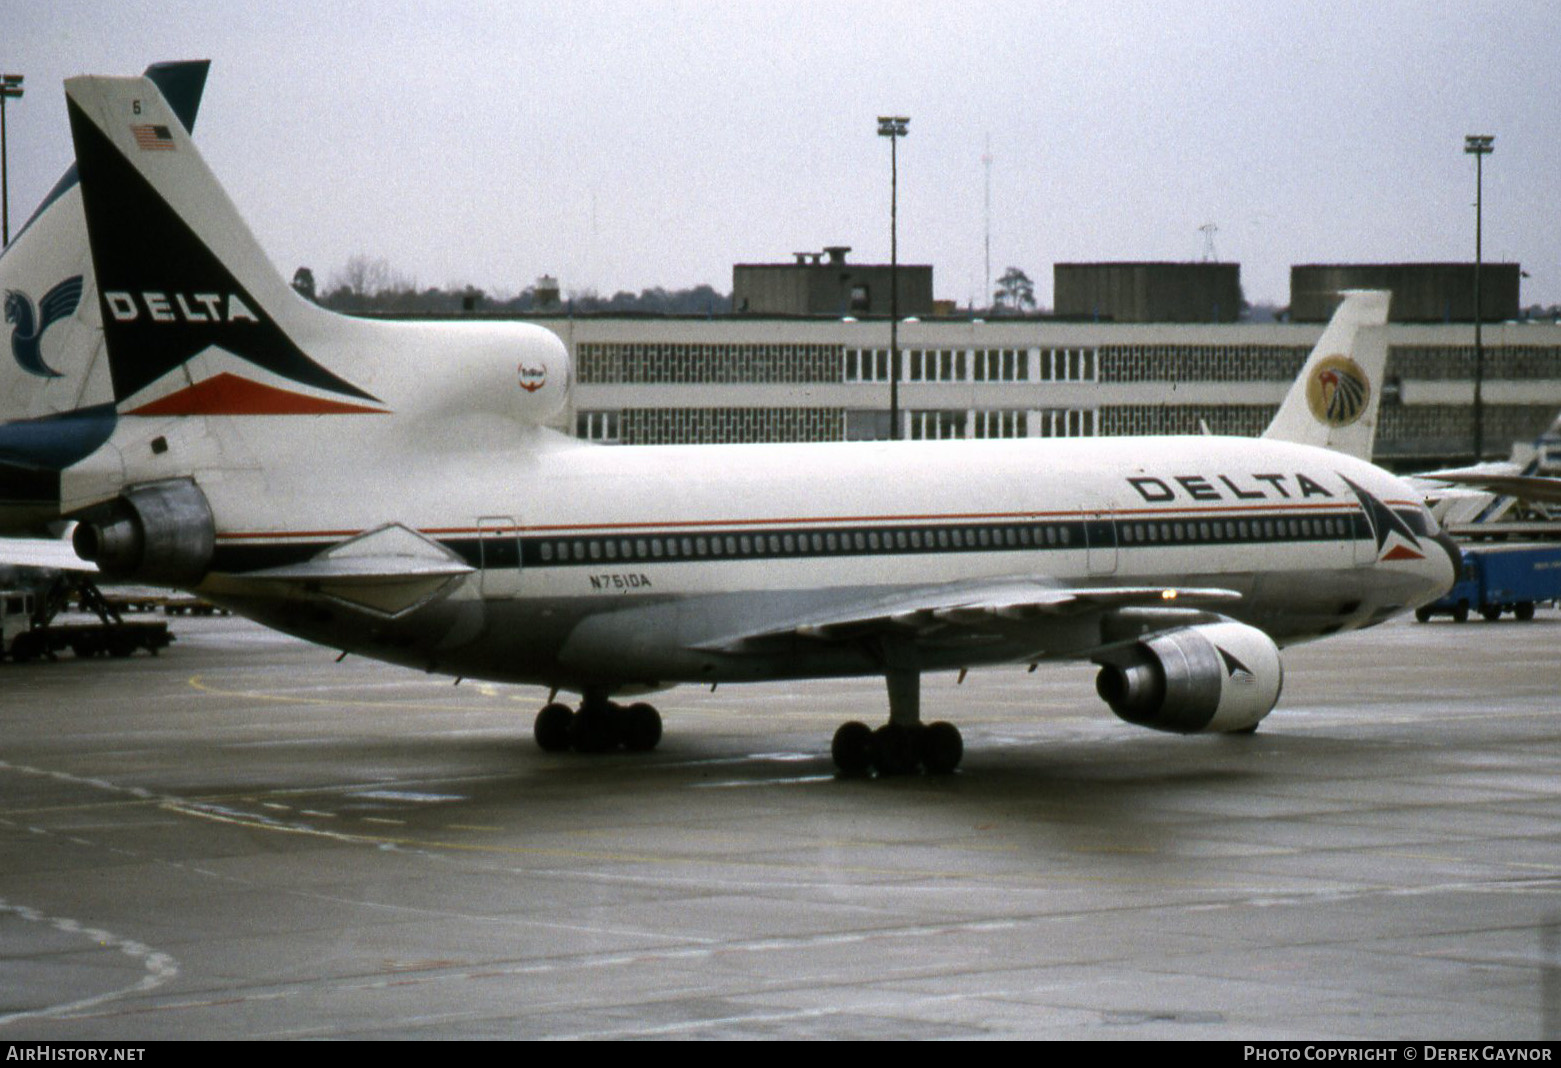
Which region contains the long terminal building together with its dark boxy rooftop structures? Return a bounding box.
[405,259,1561,467]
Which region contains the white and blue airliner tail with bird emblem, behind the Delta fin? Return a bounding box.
[0,59,211,534]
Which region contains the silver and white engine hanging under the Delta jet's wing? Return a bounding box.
[1094,623,1285,734]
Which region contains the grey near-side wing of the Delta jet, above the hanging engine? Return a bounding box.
[699,581,1241,653]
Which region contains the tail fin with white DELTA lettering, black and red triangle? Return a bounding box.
[66,78,384,415]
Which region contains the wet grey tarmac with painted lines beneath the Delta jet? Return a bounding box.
[0,609,1561,1040]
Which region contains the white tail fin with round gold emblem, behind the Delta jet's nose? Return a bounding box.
[1263,289,1392,461]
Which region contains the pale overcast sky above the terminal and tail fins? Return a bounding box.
[12,0,1561,304]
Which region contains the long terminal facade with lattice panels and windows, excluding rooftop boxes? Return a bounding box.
[543,310,1561,462]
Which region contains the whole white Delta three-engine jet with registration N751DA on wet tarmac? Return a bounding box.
[9,78,1453,773]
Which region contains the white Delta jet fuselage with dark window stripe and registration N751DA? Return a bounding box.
[134,417,1452,689]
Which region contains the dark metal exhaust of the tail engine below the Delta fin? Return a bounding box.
[72,478,217,586]
